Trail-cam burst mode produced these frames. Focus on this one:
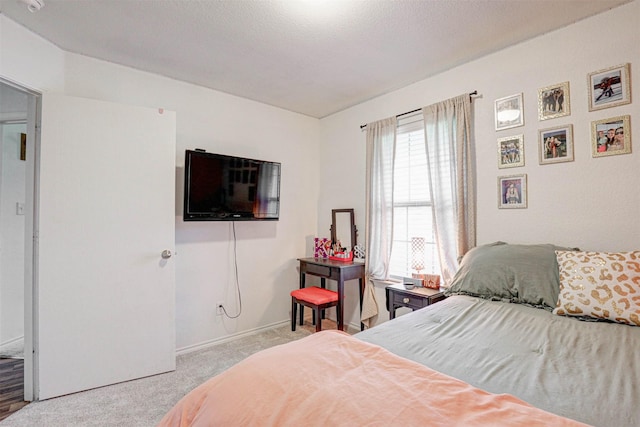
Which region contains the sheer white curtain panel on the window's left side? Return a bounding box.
[361,117,398,327]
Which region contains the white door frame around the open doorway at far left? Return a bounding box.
[0,76,42,401]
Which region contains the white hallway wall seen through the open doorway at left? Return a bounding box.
[0,124,26,344]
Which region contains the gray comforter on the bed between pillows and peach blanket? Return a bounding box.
[356,296,640,427]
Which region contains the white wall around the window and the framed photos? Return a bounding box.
[318,0,640,328]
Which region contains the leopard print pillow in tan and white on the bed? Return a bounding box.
[553,251,640,326]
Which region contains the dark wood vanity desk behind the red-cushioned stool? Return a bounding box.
[298,258,364,331]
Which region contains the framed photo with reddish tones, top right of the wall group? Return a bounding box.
[587,64,631,111]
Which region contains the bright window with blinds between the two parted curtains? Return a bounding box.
[389,115,440,277]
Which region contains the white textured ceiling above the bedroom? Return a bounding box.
[0,0,629,118]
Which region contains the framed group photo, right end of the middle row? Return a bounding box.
[591,115,631,157]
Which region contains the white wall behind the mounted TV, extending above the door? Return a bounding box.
[0,15,320,349]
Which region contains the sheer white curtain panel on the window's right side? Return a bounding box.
[422,94,476,284]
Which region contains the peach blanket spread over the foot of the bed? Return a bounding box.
[159,330,584,427]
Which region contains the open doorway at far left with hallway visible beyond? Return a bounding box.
[0,79,37,419]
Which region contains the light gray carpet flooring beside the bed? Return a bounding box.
[0,320,344,427]
